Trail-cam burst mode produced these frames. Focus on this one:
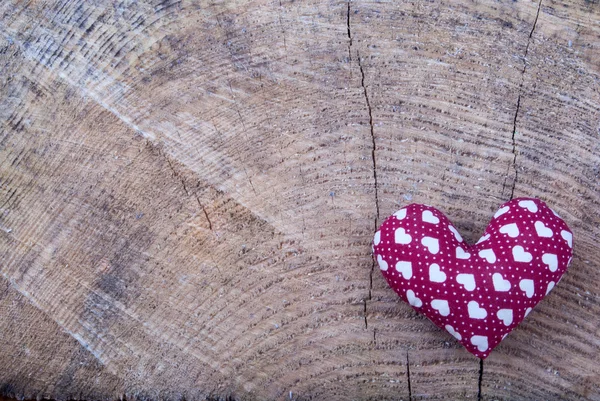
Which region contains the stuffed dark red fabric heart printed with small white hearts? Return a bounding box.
[373,198,573,359]
